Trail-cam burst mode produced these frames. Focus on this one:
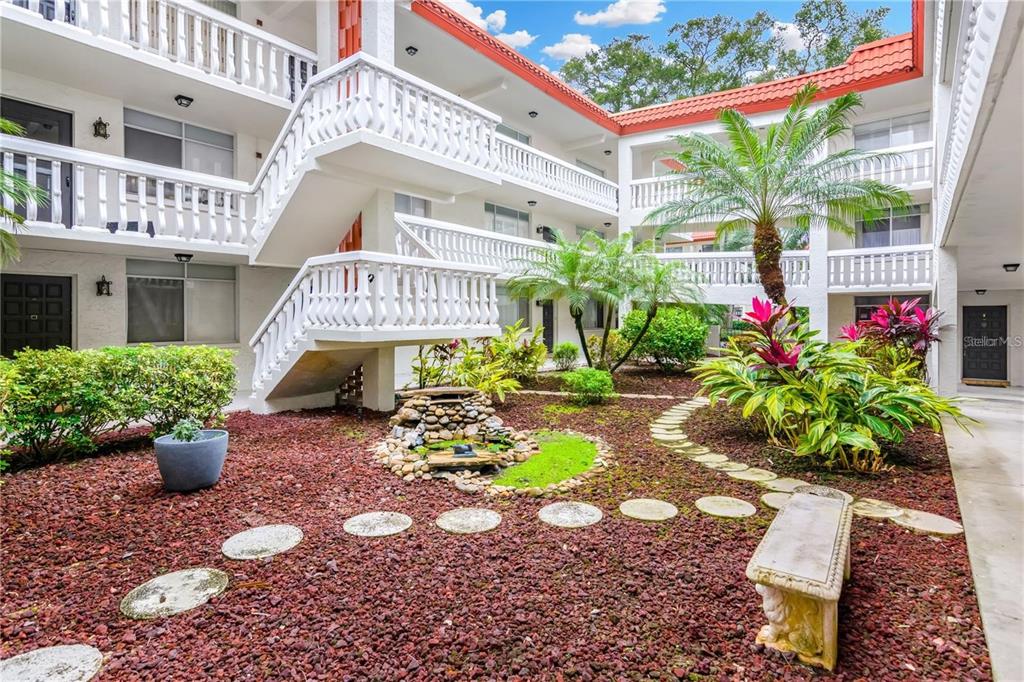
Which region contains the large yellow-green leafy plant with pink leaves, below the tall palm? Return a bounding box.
[694,299,970,471]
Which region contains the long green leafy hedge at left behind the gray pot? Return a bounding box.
[0,345,236,458]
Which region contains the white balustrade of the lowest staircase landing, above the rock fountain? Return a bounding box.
[249,251,498,389]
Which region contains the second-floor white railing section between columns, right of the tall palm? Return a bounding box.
[828,244,933,290]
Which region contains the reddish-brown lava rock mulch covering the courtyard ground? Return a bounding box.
[0,377,990,680]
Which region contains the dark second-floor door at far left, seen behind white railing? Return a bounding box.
[0,97,75,227]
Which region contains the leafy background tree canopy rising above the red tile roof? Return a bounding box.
[561,0,889,112]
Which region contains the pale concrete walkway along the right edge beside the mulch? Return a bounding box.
[945,398,1024,681]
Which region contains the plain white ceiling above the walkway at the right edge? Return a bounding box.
[945,34,1024,291]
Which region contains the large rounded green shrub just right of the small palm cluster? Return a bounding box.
[622,307,708,370]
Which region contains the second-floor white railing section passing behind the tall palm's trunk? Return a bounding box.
[657,251,810,287]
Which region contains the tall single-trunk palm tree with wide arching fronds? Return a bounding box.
[647,84,910,305]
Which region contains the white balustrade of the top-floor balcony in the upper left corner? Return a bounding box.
[0,0,316,101]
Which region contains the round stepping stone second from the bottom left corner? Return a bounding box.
[121,568,228,621]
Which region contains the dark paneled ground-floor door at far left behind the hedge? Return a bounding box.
[0,274,71,357]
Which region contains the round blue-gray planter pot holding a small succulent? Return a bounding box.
[153,429,227,493]
